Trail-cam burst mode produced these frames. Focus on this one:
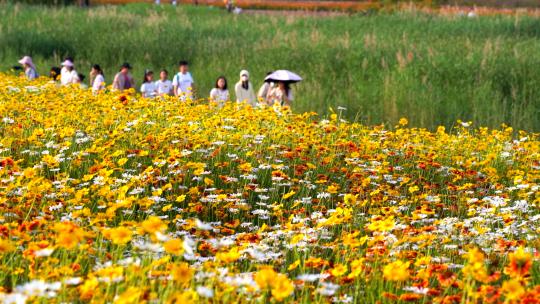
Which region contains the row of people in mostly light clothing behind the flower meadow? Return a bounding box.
[19,56,293,106]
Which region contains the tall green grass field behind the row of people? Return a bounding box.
[0,5,540,131]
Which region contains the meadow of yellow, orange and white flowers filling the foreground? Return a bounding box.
[0,75,540,303]
